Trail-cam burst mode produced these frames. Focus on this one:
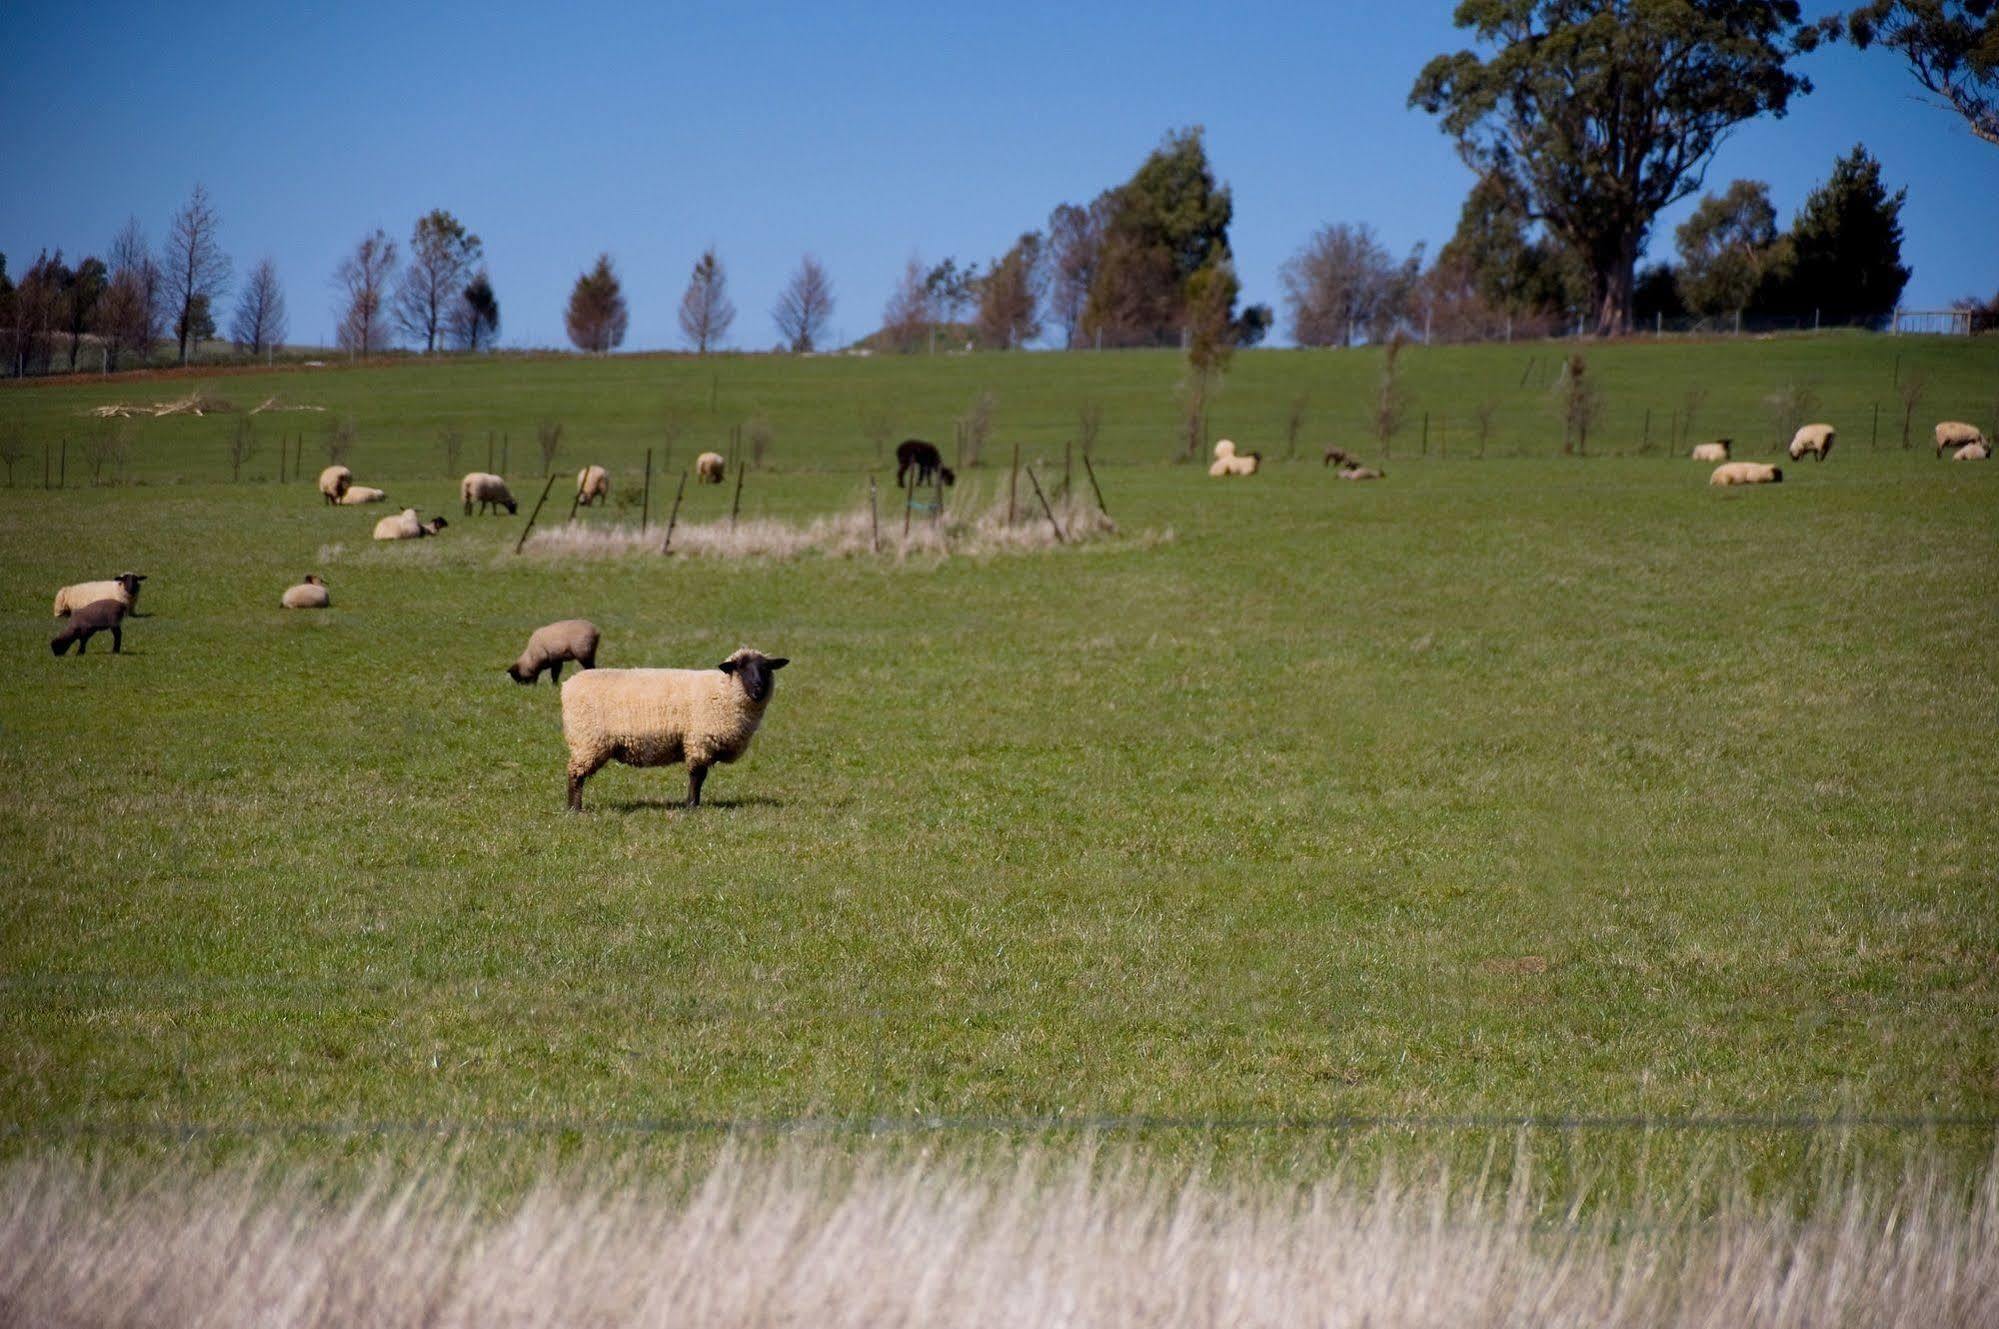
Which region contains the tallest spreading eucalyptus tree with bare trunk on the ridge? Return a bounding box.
[1409,0,1819,336]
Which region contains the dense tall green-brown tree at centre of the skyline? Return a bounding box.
[1083,126,1235,346]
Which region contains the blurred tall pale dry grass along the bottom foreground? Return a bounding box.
[0,1153,1999,1329]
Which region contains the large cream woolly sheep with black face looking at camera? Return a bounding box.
[562,648,790,811]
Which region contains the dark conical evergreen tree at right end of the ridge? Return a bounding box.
[1775,146,1909,322]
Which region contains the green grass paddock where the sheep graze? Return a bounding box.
[0,336,1999,1191]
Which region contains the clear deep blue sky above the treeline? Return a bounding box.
[0,0,1999,350]
